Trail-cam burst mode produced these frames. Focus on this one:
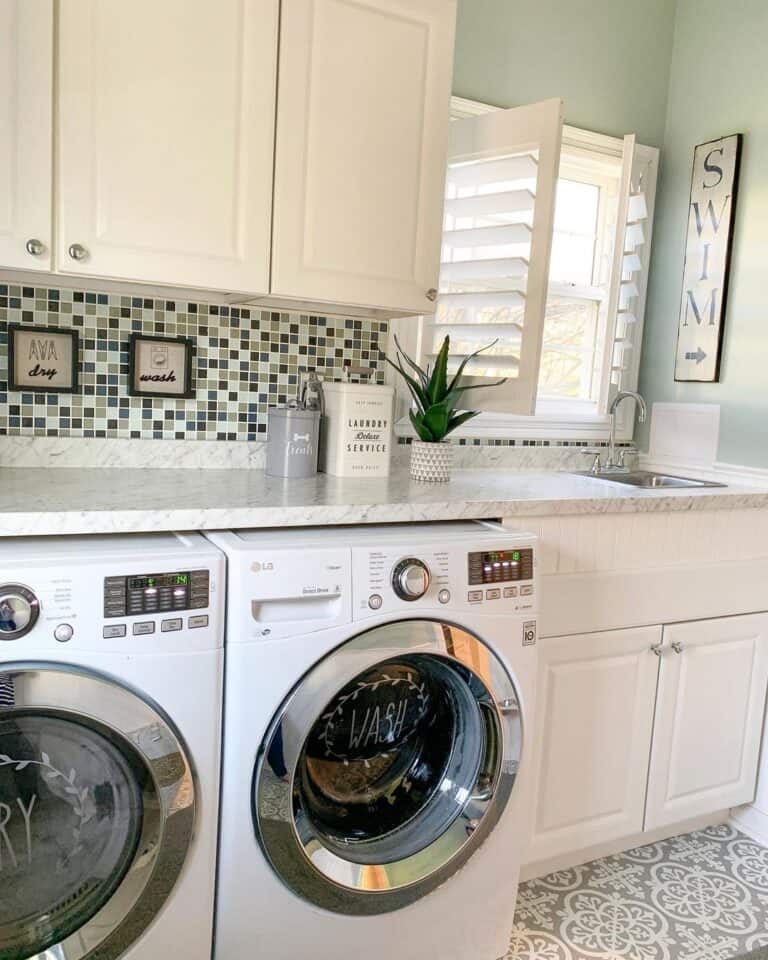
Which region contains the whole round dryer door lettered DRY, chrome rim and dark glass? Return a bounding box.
[0,665,193,960]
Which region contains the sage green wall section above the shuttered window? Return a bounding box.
[453,0,676,146]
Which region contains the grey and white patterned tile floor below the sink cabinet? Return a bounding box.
[505,825,768,960]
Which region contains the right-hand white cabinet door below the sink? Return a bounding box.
[645,614,768,830]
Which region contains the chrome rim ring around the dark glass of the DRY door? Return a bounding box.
[0,661,196,960]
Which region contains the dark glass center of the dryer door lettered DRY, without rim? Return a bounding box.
[0,713,146,956]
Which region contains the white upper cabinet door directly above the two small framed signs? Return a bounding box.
[57,0,279,293]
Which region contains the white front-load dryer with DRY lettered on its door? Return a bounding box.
[0,534,225,960]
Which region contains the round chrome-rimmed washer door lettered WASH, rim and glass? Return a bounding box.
[254,620,522,913]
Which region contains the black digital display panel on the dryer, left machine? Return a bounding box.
[104,570,210,619]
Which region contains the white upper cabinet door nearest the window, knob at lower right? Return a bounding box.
[272,0,456,315]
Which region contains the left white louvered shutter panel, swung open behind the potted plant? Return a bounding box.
[422,100,562,414]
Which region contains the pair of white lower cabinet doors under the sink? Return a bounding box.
[526,613,768,864]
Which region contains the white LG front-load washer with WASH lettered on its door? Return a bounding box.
[209,523,537,960]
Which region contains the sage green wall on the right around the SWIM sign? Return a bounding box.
[640,0,768,467]
